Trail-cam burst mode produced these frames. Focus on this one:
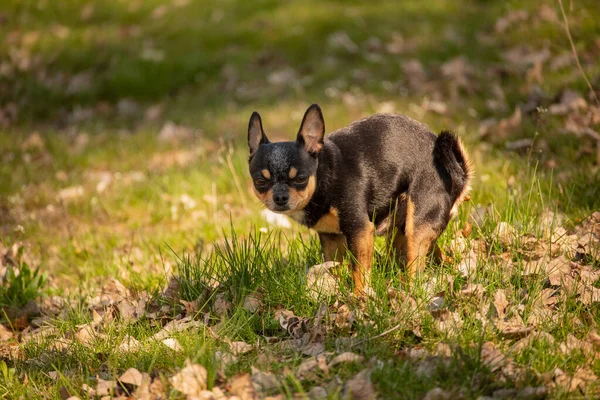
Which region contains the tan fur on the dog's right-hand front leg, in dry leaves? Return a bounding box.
[348,222,375,296]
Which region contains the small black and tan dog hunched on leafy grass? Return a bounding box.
[248,104,472,295]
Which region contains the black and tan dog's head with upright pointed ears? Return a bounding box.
[248,104,325,214]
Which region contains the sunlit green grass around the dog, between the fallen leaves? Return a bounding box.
[0,0,600,399]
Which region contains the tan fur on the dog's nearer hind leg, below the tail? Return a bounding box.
[405,197,441,278]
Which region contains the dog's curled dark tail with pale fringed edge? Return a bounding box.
[433,131,474,218]
